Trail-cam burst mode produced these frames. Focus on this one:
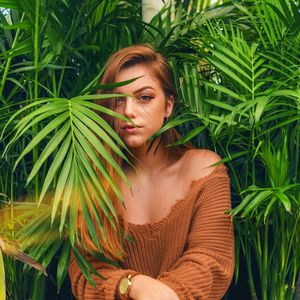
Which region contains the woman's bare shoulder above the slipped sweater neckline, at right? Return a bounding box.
[180,149,223,179]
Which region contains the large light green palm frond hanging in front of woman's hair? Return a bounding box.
[1,94,132,252]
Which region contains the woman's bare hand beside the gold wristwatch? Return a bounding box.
[129,275,179,300]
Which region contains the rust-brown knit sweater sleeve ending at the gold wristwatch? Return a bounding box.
[69,252,137,300]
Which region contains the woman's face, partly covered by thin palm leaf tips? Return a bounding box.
[114,64,174,148]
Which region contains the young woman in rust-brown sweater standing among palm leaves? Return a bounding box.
[69,45,234,300]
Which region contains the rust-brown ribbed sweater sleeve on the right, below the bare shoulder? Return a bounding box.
[157,170,234,300]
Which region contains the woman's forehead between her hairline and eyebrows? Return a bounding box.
[115,64,161,93]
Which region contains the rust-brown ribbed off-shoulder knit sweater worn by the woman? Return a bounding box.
[69,166,234,300]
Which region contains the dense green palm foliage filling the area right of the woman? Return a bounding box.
[164,1,300,299]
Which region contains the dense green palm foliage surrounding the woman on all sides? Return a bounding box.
[0,0,300,300]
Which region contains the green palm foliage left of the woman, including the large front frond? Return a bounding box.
[0,1,143,299]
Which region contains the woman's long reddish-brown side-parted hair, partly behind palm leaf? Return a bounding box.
[77,44,191,260]
